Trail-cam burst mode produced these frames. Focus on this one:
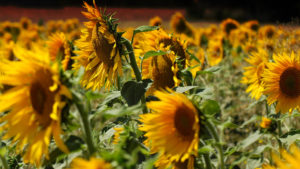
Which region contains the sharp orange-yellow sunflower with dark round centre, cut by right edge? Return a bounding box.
[262,52,300,113]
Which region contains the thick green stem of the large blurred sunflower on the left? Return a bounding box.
[72,93,96,156]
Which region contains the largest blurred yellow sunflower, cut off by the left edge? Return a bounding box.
[0,47,71,166]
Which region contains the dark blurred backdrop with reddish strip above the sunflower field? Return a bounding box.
[0,0,300,24]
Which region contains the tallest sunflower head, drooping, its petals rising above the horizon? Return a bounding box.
[73,1,122,90]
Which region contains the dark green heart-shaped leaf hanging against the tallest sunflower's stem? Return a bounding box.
[121,81,146,106]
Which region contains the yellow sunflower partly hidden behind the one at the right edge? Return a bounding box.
[241,48,268,100]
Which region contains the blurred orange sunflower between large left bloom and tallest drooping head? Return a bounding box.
[47,33,71,70]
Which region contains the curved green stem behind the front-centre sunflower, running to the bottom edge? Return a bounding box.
[205,120,225,169]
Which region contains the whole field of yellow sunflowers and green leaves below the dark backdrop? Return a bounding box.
[0,1,300,169]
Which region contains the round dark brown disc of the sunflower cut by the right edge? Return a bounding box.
[279,67,300,98]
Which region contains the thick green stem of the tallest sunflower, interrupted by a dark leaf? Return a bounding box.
[122,38,148,114]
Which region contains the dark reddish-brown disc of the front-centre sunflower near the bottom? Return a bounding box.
[175,108,195,136]
